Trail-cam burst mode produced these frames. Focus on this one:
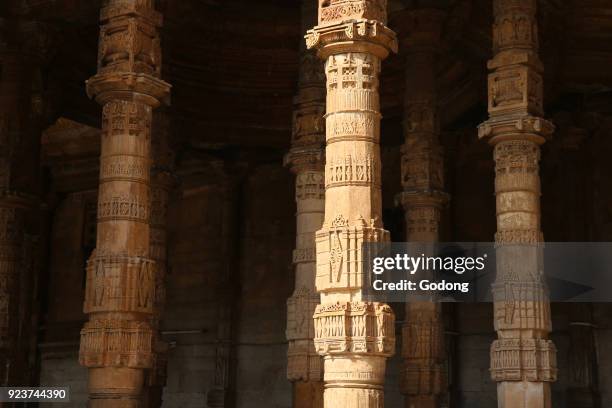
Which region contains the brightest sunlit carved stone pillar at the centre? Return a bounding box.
[306,0,397,408]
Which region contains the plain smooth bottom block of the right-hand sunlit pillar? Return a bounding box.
[497,381,551,408]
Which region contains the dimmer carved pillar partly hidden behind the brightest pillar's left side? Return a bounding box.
[285,1,325,402]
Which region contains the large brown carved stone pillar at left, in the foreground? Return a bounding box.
[79,0,170,408]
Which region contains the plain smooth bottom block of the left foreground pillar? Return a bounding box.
[88,367,144,408]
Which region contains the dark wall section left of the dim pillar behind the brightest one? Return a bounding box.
[235,165,295,408]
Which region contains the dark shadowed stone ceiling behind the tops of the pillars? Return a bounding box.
[14,0,612,156]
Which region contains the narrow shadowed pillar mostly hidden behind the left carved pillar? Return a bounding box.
[143,112,174,408]
